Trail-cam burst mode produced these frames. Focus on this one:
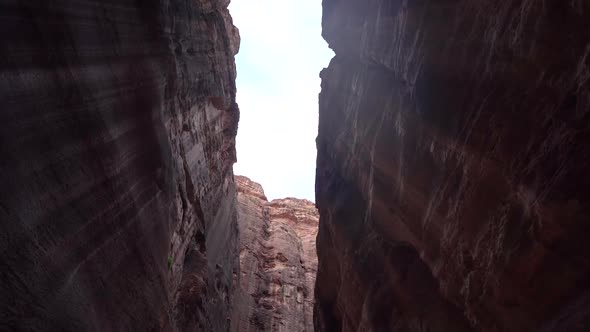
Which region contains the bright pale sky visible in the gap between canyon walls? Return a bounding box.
[229,0,334,201]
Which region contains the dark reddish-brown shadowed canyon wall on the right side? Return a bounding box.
[315,0,590,331]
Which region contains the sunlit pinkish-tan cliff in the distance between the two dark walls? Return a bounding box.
[231,176,318,332]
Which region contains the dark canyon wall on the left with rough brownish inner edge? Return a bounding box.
[0,0,239,331]
